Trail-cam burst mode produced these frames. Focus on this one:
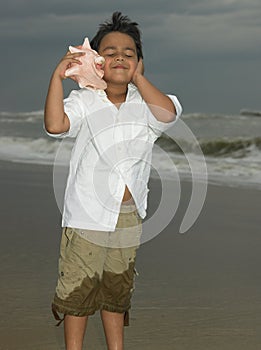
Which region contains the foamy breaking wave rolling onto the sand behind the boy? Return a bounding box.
[0,135,261,189]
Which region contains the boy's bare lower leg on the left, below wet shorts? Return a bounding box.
[64,315,88,350]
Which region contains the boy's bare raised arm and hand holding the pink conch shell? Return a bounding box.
[44,52,83,134]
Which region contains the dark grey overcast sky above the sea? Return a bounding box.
[0,0,261,114]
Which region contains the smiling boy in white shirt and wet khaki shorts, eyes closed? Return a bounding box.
[45,12,181,350]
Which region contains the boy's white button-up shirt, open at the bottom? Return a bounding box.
[47,84,182,231]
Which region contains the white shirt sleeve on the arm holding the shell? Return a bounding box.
[45,90,84,138]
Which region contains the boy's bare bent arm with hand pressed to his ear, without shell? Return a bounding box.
[132,59,176,123]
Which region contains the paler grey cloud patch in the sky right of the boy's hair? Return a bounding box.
[140,0,261,59]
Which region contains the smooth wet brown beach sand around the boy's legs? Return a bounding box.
[0,162,261,350]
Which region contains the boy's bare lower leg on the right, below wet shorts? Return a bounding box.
[101,310,124,350]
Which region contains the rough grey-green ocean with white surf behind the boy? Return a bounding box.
[0,111,261,189]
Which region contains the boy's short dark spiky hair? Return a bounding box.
[90,12,143,59]
